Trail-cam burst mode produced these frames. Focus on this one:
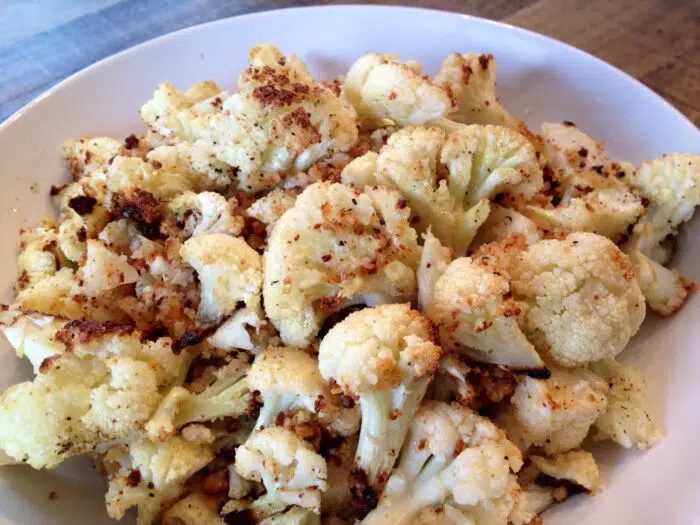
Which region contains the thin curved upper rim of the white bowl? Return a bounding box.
[0,4,700,140]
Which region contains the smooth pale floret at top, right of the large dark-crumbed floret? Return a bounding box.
[343,53,452,128]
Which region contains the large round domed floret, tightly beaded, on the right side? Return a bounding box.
[510,233,646,366]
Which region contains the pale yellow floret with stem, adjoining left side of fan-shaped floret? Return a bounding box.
[341,127,489,254]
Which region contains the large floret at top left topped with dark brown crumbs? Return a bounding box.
[209,45,358,193]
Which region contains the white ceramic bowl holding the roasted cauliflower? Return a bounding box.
[0,6,700,525]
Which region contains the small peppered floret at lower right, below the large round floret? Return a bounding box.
[591,359,664,450]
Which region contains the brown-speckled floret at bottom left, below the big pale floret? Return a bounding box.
[102,437,214,525]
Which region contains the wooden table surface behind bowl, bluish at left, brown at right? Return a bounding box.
[0,0,700,125]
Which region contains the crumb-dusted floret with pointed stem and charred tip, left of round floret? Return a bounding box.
[427,250,544,369]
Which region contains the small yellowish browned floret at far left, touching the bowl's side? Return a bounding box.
[17,221,59,290]
